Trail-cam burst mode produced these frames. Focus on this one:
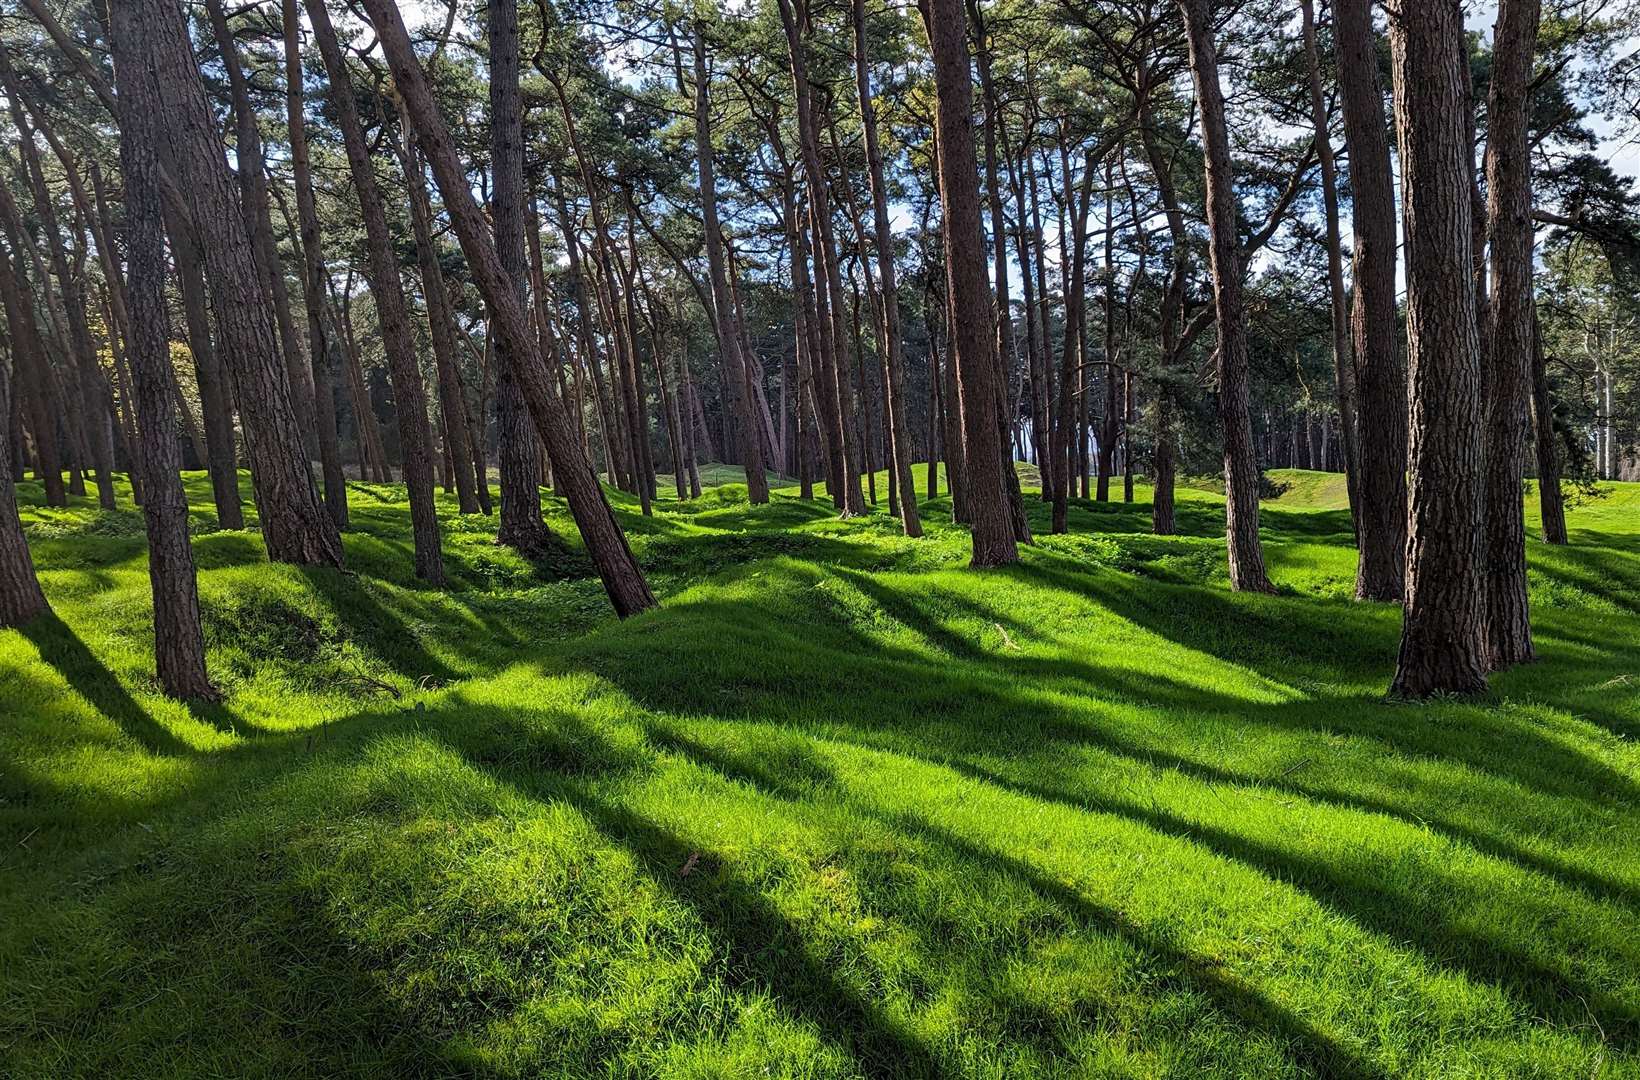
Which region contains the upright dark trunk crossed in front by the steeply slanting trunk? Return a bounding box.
[488,0,556,552]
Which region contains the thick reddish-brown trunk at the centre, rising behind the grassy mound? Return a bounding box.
[922,0,1018,567]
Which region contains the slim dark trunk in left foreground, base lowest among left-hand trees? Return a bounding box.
[112,3,216,698]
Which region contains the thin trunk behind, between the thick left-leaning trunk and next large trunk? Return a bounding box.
[280,0,348,529]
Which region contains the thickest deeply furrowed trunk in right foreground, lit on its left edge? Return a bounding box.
[1389,0,1487,698]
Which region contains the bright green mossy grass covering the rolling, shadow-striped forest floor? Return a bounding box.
[0,469,1640,1078]
